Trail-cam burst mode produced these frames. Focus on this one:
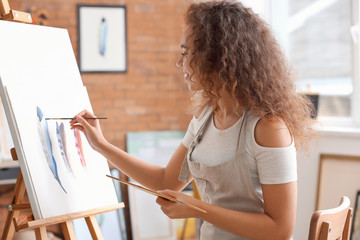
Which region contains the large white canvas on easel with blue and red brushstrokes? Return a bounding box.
[0,21,118,219]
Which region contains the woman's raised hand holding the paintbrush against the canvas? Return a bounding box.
[70,110,107,151]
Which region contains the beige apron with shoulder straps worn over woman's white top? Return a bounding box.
[179,112,264,240]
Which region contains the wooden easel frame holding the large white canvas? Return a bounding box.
[0,0,124,240]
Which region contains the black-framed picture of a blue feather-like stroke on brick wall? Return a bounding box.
[78,5,127,73]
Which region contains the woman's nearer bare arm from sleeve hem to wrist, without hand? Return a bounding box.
[200,182,297,240]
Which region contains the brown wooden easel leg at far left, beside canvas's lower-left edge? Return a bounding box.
[1,171,25,240]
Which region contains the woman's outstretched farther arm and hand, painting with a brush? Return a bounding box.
[70,110,187,191]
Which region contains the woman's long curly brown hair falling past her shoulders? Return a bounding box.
[185,0,314,148]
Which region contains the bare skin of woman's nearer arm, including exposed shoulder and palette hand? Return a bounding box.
[157,117,297,240]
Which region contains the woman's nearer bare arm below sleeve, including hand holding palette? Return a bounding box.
[156,182,297,240]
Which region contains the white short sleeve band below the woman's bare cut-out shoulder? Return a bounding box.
[256,143,297,184]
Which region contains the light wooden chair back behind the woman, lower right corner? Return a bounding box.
[309,196,353,240]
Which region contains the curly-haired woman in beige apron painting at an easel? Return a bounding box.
[71,1,311,240]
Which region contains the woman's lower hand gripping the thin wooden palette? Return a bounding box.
[156,189,203,219]
